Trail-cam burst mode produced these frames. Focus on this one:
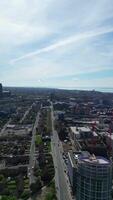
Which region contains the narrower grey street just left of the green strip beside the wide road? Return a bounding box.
[28,112,40,185]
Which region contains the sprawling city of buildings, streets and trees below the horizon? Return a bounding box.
[0,84,113,200]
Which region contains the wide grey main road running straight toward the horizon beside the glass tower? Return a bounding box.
[51,103,72,200]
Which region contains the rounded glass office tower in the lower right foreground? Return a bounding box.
[76,156,112,200]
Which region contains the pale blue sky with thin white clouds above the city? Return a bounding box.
[0,0,113,88]
